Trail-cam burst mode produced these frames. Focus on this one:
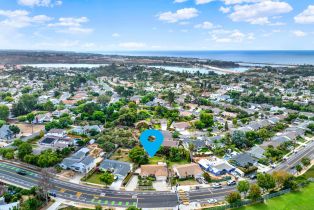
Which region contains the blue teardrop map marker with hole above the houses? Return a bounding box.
[140,130,164,157]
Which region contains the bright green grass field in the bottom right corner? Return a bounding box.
[237,183,314,210]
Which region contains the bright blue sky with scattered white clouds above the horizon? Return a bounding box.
[0,0,314,51]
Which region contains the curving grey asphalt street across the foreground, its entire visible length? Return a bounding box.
[0,142,314,208]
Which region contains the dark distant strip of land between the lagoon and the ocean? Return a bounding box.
[0,50,239,68]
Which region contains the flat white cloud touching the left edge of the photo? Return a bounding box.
[0,10,53,28]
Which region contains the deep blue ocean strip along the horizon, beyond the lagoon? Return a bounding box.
[98,50,314,65]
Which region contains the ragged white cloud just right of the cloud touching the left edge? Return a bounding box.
[48,17,94,34]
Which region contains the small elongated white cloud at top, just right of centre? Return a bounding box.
[158,8,199,23]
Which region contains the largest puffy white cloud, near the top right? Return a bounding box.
[229,0,293,25]
